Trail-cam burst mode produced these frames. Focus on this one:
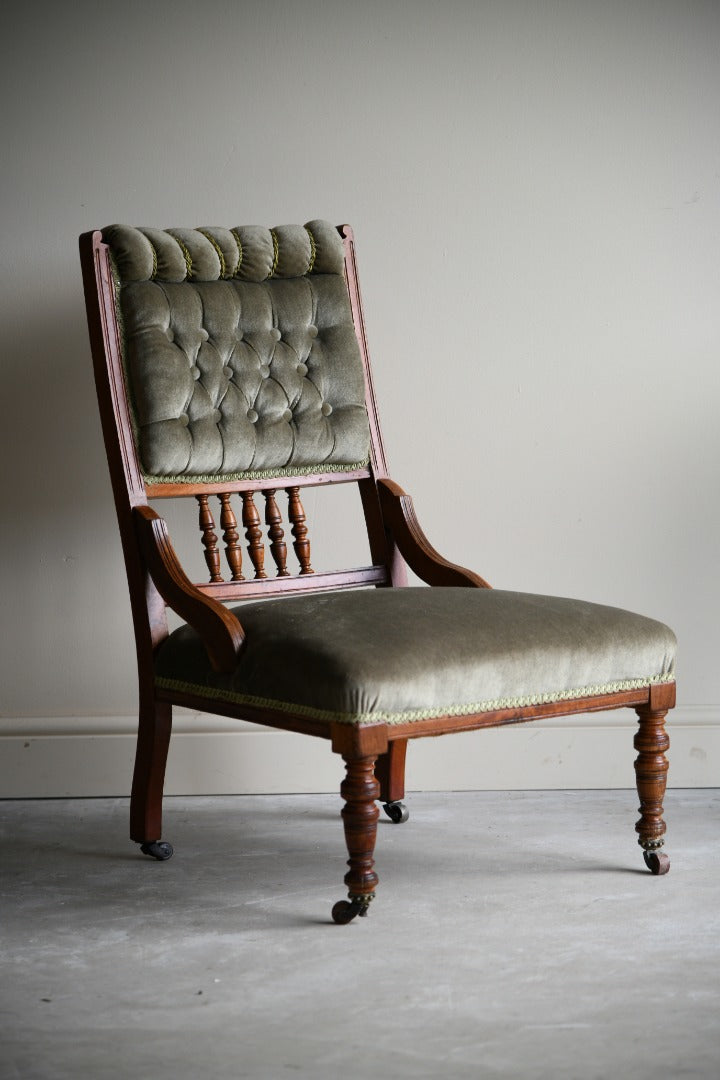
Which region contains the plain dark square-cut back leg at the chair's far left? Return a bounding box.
[130,699,173,860]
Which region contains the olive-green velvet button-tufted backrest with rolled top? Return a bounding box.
[103,221,369,484]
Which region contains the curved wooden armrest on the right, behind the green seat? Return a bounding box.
[378,480,490,589]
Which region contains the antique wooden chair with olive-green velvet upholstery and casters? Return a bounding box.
[80,221,675,923]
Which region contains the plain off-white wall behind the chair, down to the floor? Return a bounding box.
[0,0,720,794]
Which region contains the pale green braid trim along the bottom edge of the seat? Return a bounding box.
[155,674,675,727]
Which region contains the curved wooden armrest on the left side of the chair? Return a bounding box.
[133,507,245,672]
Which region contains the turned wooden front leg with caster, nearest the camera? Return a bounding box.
[332,757,380,923]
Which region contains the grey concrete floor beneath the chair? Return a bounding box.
[0,791,720,1080]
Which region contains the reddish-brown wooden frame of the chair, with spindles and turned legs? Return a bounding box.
[80,226,675,922]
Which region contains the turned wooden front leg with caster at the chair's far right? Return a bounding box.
[634,705,670,875]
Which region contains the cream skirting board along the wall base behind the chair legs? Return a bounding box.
[0,705,720,798]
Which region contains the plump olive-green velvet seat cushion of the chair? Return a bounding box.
[155,588,676,725]
